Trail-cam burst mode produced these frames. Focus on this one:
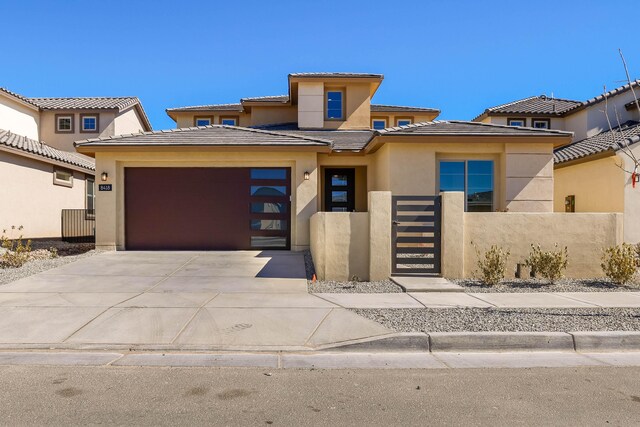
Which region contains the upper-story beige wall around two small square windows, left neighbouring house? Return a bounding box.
[40,110,115,151]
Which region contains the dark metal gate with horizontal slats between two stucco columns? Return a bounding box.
[391,196,441,275]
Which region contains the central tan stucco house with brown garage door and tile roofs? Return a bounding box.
[76,73,572,277]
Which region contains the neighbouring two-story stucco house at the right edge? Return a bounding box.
[474,81,640,243]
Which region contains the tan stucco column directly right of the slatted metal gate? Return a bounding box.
[440,191,464,278]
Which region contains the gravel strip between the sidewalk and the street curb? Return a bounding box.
[352,308,640,332]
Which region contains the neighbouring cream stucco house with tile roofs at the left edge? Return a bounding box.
[0,88,151,238]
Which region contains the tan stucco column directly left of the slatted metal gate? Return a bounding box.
[369,191,391,280]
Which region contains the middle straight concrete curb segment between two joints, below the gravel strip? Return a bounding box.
[429,332,574,352]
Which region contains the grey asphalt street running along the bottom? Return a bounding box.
[0,366,640,425]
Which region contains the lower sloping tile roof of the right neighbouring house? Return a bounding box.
[553,121,640,163]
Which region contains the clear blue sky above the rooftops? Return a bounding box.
[0,0,640,129]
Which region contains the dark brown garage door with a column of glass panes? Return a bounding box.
[125,168,291,250]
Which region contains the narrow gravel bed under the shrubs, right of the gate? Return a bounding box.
[458,279,640,293]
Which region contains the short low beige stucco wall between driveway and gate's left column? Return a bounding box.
[311,212,369,280]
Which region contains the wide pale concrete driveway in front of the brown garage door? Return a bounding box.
[0,251,391,350]
